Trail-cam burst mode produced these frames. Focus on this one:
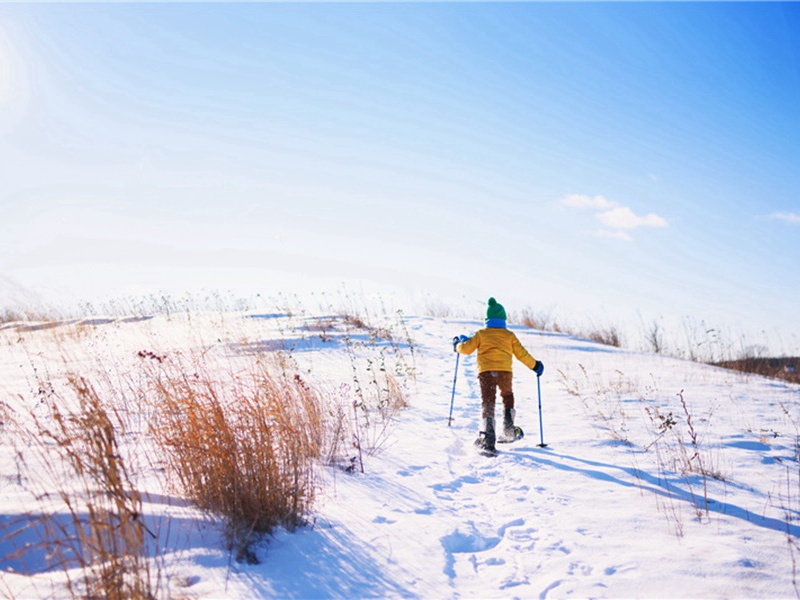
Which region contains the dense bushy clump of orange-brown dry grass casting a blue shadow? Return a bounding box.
[146,358,327,560]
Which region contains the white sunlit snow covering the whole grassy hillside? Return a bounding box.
[0,310,800,598]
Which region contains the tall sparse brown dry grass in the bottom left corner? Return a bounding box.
[6,375,157,599]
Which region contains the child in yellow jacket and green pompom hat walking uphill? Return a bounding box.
[453,298,544,452]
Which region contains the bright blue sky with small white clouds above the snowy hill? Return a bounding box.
[0,3,800,346]
